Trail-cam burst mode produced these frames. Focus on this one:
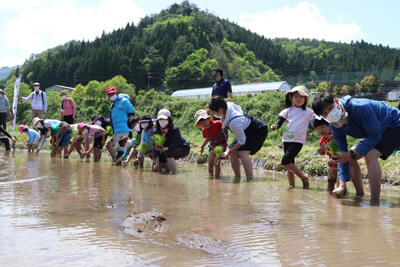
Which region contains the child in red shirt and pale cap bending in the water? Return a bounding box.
[194,109,228,178]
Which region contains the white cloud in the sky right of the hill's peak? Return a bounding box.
[239,2,363,42]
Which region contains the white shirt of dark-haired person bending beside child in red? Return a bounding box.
[222,102,251,145]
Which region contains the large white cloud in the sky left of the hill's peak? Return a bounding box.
[0,0,144,54]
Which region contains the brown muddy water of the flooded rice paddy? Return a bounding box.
[0,151,400,266]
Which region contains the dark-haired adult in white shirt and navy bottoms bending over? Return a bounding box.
[208,97,268,179]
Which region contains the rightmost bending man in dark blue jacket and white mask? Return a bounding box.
[312,93,400,202]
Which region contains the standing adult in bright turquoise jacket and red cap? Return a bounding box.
[107,86,135,164]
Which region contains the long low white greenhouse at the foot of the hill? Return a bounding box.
[171,81,292,98]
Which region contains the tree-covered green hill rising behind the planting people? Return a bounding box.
[6,1,400,91]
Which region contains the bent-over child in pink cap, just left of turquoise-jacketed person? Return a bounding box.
[78,123,106,162]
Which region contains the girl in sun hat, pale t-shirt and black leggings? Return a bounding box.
[271,86,314,189]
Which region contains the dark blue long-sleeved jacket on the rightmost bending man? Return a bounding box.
[331,96,400,180]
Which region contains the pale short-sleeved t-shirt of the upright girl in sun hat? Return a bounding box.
[279,107,314,144]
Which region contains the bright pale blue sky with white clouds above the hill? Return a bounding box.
[0,0,400,67]
